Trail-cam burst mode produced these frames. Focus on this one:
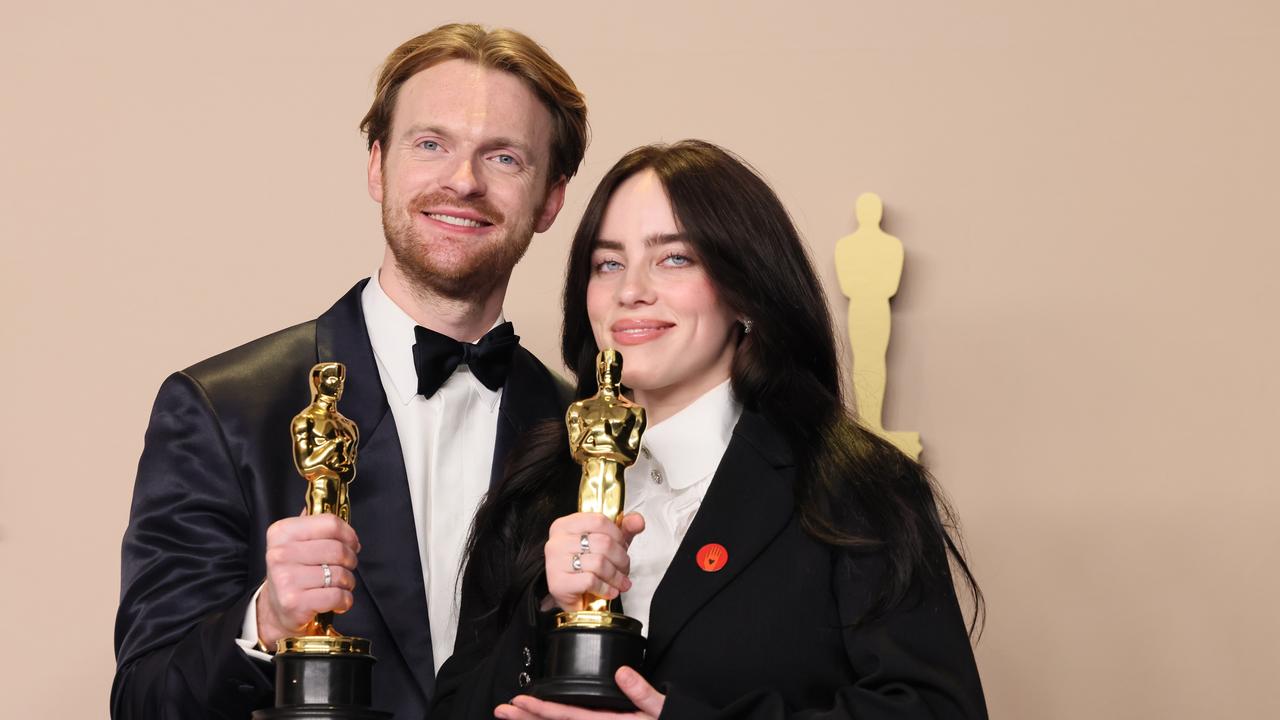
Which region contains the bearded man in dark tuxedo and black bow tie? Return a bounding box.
[111,24,586,717]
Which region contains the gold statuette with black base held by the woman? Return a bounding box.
[529,350,645,710]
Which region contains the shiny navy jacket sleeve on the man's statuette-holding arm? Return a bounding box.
[111,373,271,719]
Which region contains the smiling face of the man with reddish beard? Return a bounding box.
[369,60,564,301]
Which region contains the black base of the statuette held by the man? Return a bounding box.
[253,652,390,720]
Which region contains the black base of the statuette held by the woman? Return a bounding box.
[529,626,644,711]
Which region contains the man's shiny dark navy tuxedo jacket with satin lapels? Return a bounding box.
[111,282,567,720]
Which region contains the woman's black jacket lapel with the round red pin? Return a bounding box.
[645,413,795,669]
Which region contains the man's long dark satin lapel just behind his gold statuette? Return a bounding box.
[316,282,435,697]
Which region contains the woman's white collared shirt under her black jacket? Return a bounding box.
[622,380,742,634]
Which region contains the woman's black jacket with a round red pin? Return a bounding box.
[431,413,987,720]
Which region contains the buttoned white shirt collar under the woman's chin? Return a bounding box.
[640,380,742,489]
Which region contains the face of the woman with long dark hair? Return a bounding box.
[586,170,737,423]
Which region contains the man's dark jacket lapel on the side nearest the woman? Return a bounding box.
[489,347,568,489]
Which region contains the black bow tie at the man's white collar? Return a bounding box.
[413,323,520,397]
